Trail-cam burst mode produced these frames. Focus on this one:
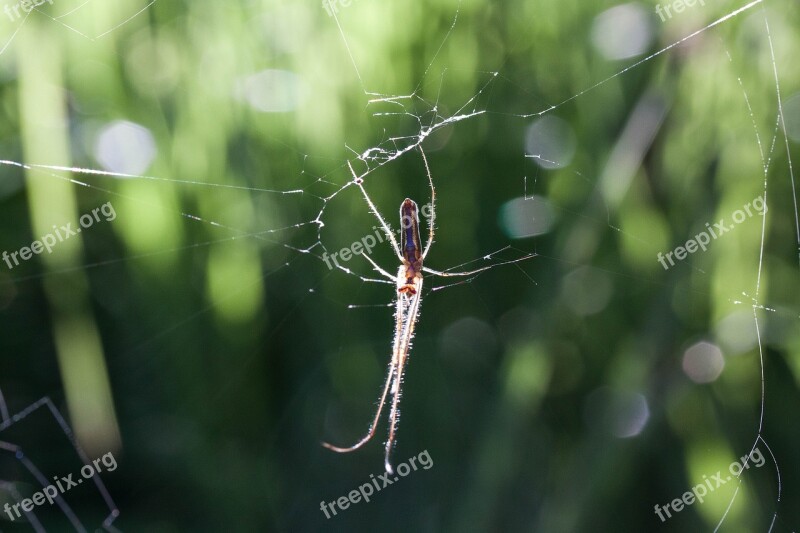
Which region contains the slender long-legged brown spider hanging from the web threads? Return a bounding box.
[322,147,532,474]
